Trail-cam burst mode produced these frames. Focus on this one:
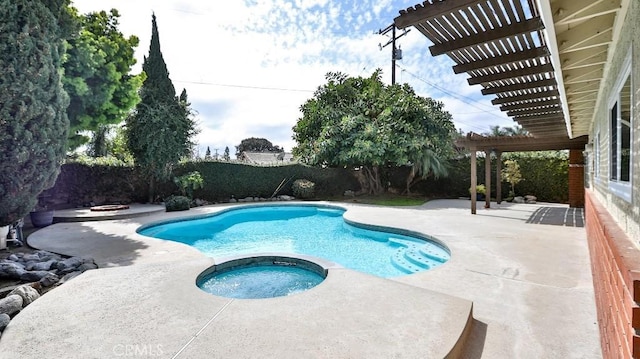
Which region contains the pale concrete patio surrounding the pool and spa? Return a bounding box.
[0,200,601,358]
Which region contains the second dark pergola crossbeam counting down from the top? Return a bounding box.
[429,17,544,56]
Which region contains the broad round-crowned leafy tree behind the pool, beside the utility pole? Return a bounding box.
[293,70,455,194]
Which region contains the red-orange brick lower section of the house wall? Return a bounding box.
[585,191,640,358]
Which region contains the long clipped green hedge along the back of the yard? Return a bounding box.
[46,151,569,208]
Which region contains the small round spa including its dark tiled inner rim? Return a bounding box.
[196,255,327,299]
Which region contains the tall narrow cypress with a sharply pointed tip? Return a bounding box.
[127,15,197,201]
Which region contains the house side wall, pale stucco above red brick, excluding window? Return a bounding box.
[585,0,640,358]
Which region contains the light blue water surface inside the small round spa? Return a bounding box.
[198,264,324,299]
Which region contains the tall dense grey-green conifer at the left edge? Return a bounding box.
[0,0,69,226]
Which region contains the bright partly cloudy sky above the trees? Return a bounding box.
[72,0,515,156]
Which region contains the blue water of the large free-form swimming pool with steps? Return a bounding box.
[138,205,450,278]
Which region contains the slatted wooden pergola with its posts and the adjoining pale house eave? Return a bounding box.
[394,0,629,213]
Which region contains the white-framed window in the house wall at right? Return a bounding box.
[609,50,633,201]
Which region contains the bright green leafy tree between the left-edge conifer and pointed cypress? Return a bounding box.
[63,9,144,149]
